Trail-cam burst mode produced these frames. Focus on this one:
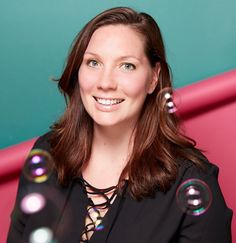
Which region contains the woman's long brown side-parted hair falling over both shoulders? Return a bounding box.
[50,7,203,199]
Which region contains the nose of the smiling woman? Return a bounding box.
[97,70,117,90]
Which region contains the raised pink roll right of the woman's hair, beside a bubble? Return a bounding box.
[176,69,236,116]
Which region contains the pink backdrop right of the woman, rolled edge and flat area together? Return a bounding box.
[175,70,236,243]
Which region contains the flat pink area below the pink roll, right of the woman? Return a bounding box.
[184,101,236,242]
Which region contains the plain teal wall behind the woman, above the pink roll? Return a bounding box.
[0,0,236,148]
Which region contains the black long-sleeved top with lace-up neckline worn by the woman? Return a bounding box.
[7,135,232,243]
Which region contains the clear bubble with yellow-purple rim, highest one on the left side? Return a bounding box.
[23,149,53,183]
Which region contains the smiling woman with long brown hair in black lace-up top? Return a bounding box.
[8,7,232,243]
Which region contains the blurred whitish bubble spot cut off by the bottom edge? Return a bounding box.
[29,227,54,243]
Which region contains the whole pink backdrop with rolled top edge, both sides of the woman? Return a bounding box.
[0,70,236,243]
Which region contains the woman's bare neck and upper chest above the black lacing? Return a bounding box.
[83,122,133,188]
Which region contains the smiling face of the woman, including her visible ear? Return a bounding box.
[78,25,159,129]
